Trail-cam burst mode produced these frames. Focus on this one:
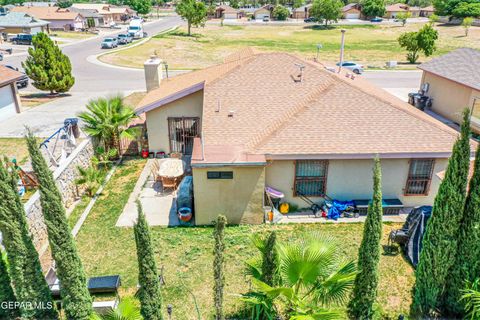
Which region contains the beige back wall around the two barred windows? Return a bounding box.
[266,159,448,208]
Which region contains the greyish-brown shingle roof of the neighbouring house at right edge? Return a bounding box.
[418,48,480,90]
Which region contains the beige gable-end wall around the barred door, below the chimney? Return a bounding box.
[142,90,203,153]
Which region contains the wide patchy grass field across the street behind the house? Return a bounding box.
[100,23,480,69]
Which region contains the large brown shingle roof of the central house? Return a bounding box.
[138,52,468,163]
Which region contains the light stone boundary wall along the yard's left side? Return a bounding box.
[25,139,93,270]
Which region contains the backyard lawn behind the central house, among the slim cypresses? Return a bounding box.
[77,160,414,320]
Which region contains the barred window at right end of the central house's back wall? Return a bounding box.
[405,159,435,196]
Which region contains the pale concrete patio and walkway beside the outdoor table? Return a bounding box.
[116,159,179,227]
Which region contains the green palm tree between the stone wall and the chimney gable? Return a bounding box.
[78,96,137,150]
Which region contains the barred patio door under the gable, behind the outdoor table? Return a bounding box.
[168,117,200,156]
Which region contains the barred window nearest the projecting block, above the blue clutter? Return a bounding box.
[294,160,328,197]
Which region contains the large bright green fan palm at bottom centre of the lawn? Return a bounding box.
[245,233,356,320]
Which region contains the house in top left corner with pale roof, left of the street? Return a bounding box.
[0,12,50,34]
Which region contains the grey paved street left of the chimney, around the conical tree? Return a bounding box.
[0,17,182,137]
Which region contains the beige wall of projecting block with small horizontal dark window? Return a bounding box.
[193,166,265,225]
